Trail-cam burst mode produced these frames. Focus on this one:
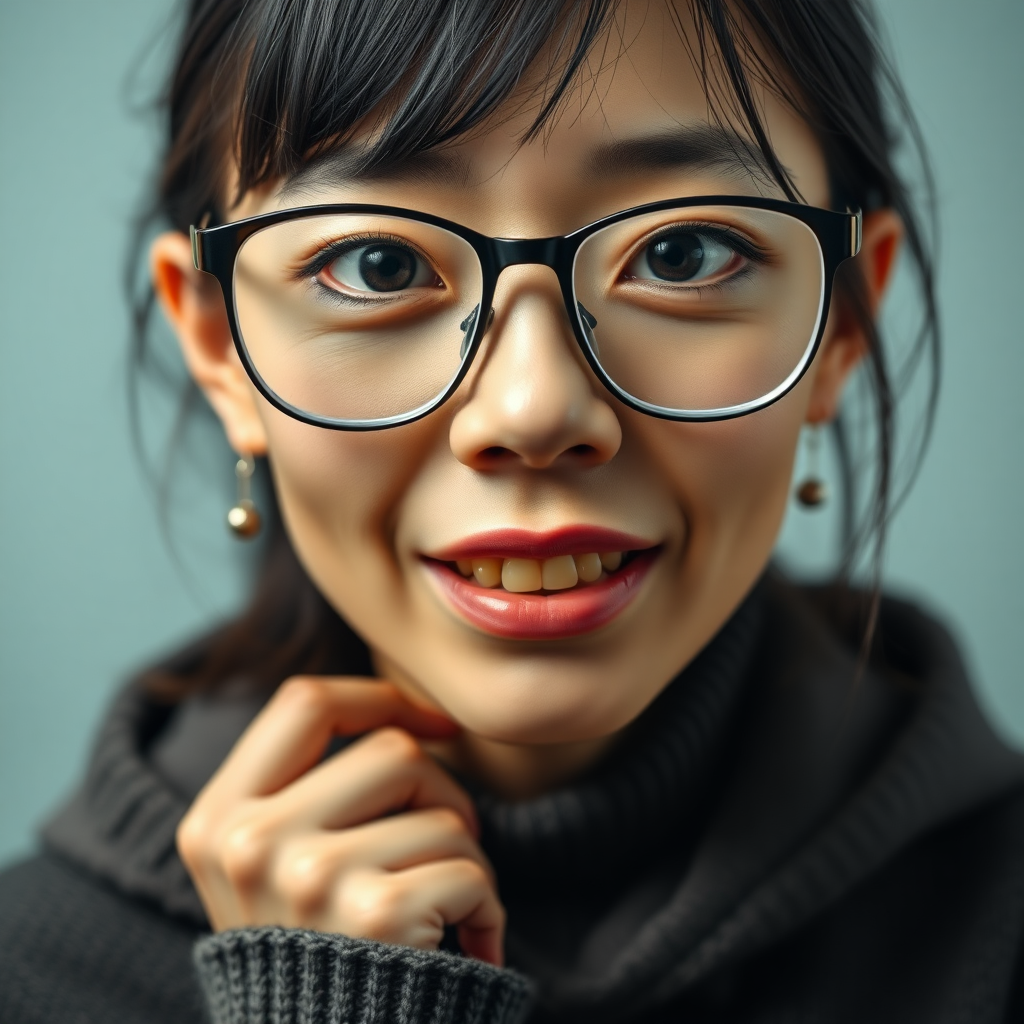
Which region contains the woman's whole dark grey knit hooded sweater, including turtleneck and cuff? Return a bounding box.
[0,581,1024,1024]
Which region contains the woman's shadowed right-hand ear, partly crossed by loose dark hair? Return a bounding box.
[807,209,903,423]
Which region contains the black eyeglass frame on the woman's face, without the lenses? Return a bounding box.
[189,196,863,431]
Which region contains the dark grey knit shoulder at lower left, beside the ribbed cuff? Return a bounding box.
[0,855,205,1024]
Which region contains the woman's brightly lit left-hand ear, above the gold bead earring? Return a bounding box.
[150,231,266,455]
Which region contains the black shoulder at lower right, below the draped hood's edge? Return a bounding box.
[712,787,1024,1024]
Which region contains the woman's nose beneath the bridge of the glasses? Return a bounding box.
[450,265,623,470]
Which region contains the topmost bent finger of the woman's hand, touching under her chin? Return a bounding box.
[207,677,458,801]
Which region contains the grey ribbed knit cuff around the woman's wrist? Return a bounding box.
[194,928,531,1024]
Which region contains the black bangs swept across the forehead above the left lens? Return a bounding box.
[227,0,615,196]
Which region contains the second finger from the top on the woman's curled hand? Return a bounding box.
[258,728,479,837]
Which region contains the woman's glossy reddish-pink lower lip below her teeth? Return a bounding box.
[424,548,657,640]
